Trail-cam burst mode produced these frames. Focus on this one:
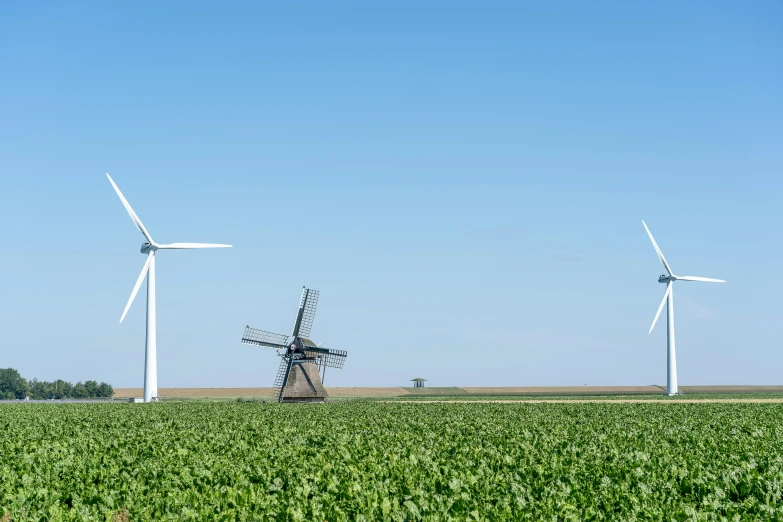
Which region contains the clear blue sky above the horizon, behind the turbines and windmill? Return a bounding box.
[0,1,783,387]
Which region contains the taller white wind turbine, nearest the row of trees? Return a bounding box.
[106,173,231,402]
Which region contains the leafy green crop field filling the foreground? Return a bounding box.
[0,401,783,521]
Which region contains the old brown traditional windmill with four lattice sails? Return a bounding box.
[242,287,348,402]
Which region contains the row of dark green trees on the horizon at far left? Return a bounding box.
[0,368,114,400]
